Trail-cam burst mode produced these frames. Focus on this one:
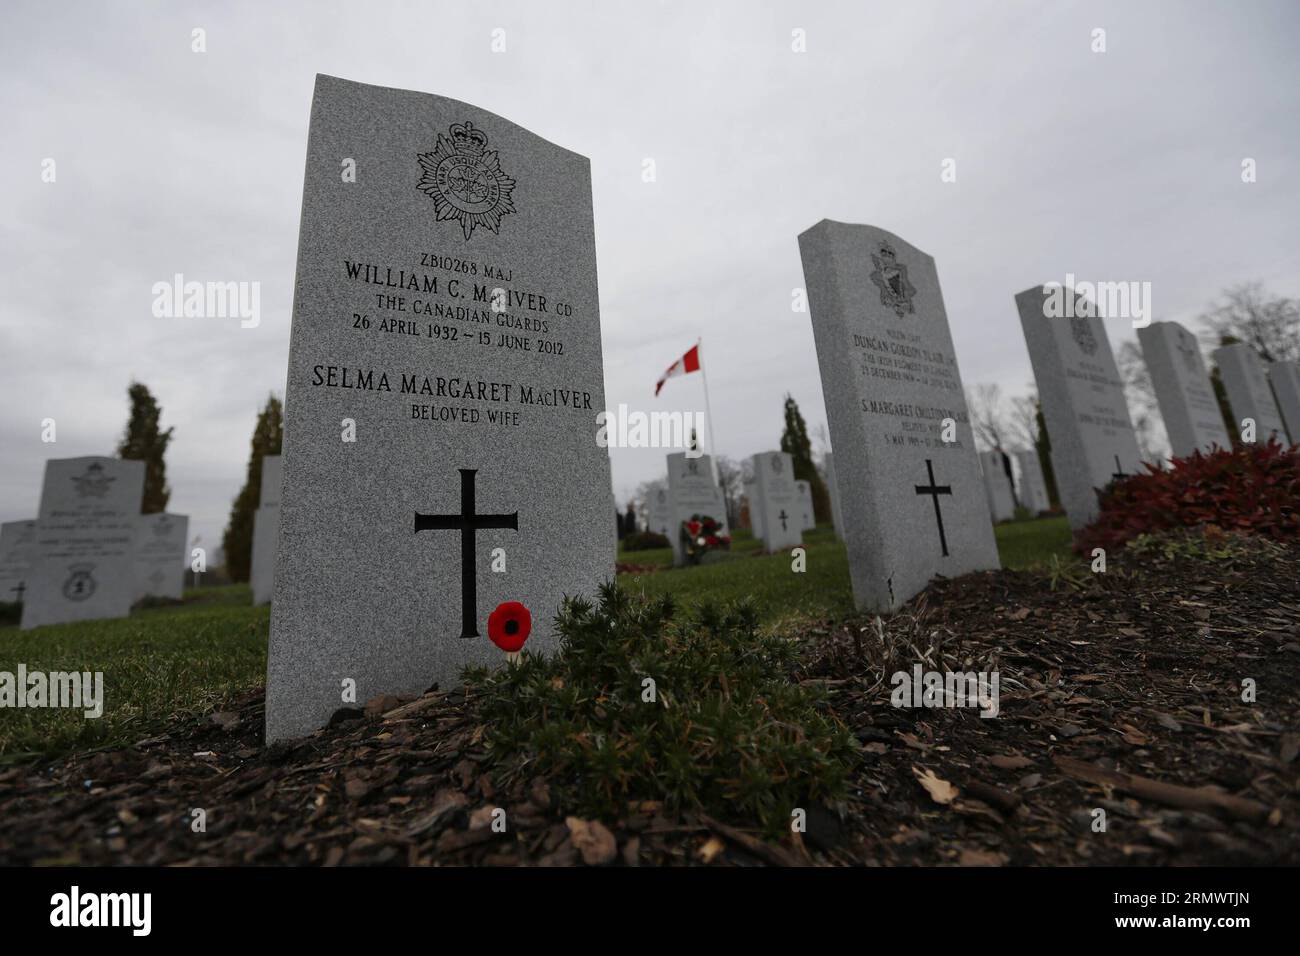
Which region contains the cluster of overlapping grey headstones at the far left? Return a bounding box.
[0,457,190,628]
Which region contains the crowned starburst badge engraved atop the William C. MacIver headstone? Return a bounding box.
[416,122,515,239]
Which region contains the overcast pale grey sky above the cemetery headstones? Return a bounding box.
[0,0,1300,542]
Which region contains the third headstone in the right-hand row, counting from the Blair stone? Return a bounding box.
[1138,323,1232,458]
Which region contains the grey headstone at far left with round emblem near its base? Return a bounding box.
[22,457,144,630]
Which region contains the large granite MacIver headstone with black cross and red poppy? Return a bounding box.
[267,75,615,740]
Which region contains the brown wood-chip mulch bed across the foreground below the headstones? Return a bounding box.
[0,538,1300,865]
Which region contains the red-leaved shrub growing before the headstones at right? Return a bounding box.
[1075,441,1300,554]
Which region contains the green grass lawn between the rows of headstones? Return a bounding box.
[0,518,1070,763]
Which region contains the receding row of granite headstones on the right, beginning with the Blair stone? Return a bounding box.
[800,220,1300,611]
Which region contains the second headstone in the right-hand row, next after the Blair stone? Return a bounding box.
[1015,286,1141,529]
